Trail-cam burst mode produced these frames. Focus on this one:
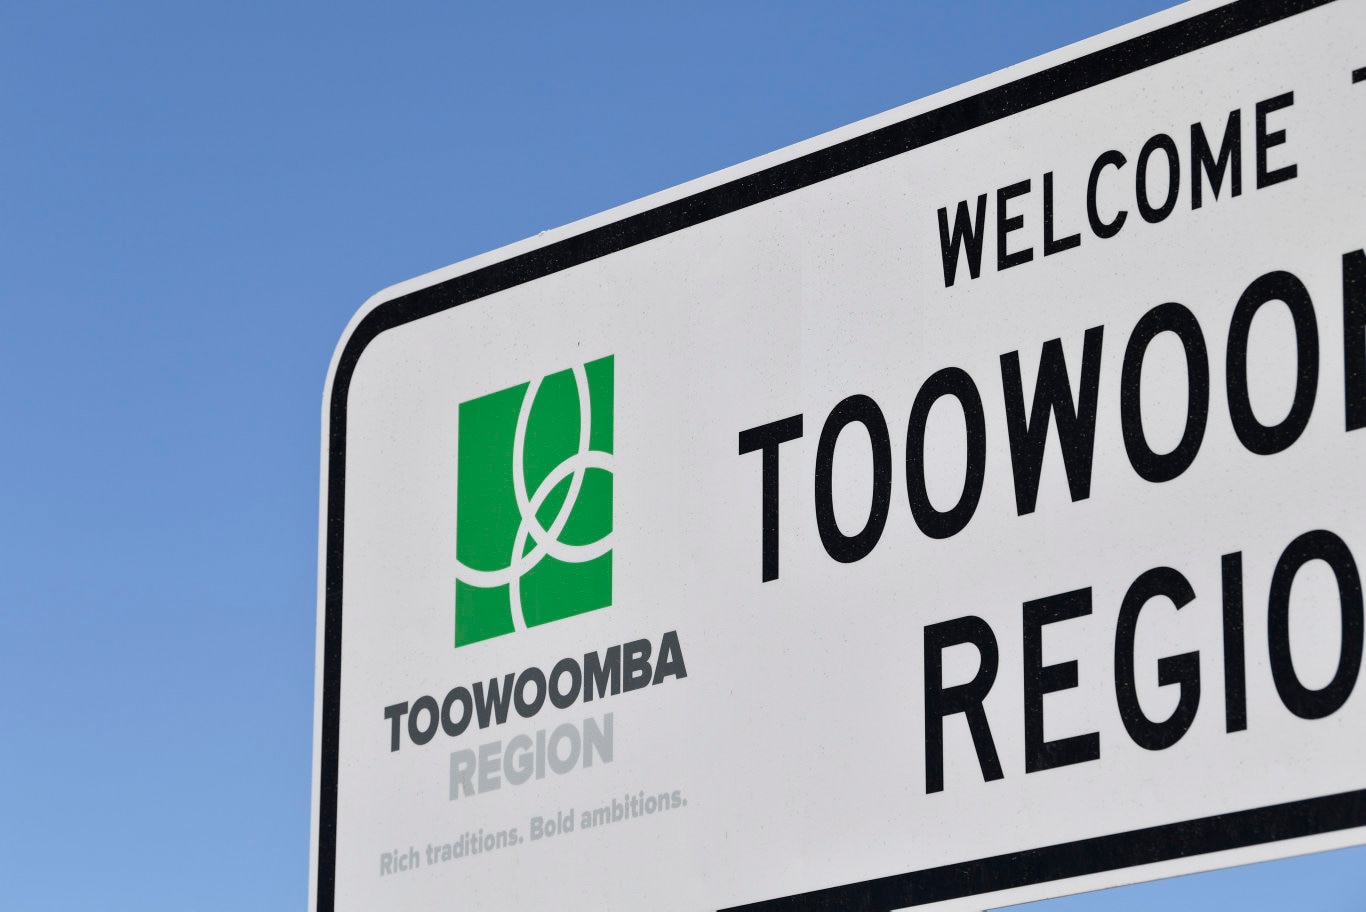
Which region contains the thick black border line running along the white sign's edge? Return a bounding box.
[316,0,1349,912]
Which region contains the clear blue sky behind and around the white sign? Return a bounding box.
[0,0,1366,912]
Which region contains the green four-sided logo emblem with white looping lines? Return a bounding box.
[455,355,613,646]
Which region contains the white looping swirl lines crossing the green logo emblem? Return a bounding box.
[455,365,612,631]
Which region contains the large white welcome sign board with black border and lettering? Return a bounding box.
[311,0,1366,912]
